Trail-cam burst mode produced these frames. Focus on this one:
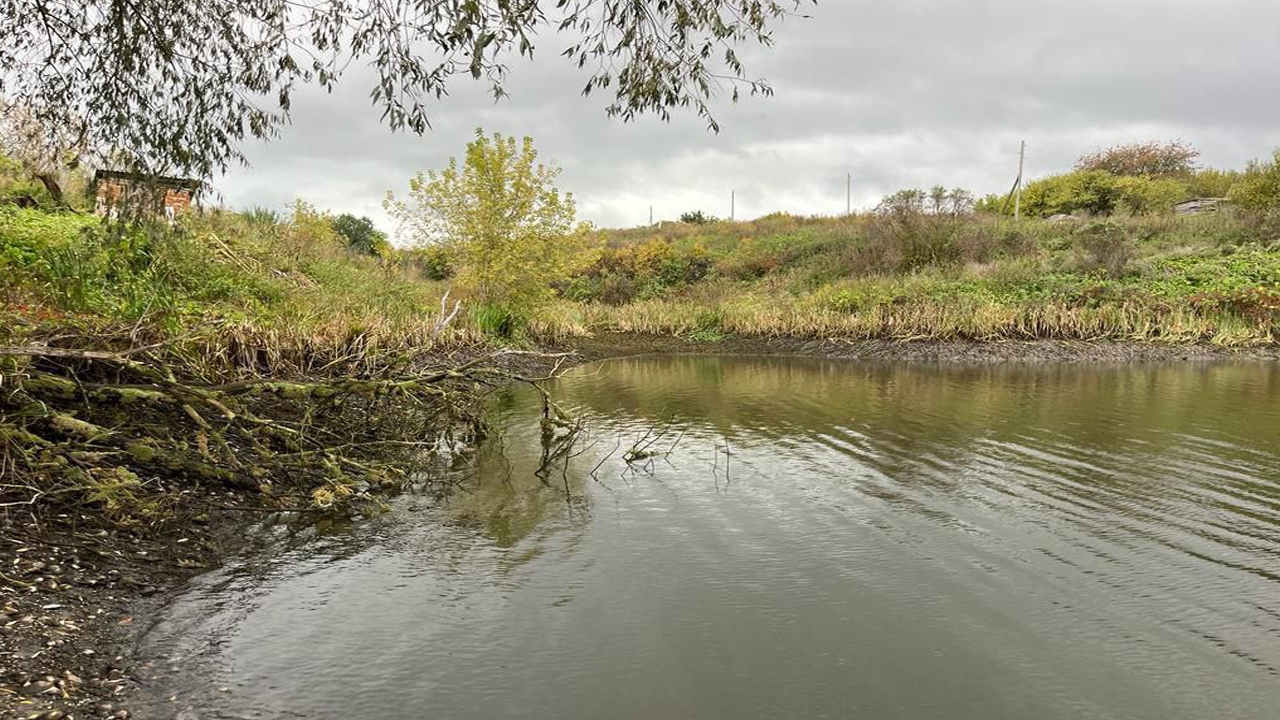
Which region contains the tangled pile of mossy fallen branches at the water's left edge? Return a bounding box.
[0,345,573,507]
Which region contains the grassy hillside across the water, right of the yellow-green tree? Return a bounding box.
[534,213,1280,346]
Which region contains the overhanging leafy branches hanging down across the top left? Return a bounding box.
[0,0,814,177]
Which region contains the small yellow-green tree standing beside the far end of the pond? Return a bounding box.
[384,129,594,313]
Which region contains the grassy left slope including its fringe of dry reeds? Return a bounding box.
[0,199,475,372]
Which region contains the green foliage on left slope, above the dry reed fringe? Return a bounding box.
[0,204,460,340]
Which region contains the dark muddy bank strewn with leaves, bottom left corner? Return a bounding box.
[0,489,255,720]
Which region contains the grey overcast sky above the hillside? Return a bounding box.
[218,0,1280,231]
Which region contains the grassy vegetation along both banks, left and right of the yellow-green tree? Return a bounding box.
[10,205,1280,351]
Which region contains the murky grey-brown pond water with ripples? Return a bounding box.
[137,357,1280,720]
